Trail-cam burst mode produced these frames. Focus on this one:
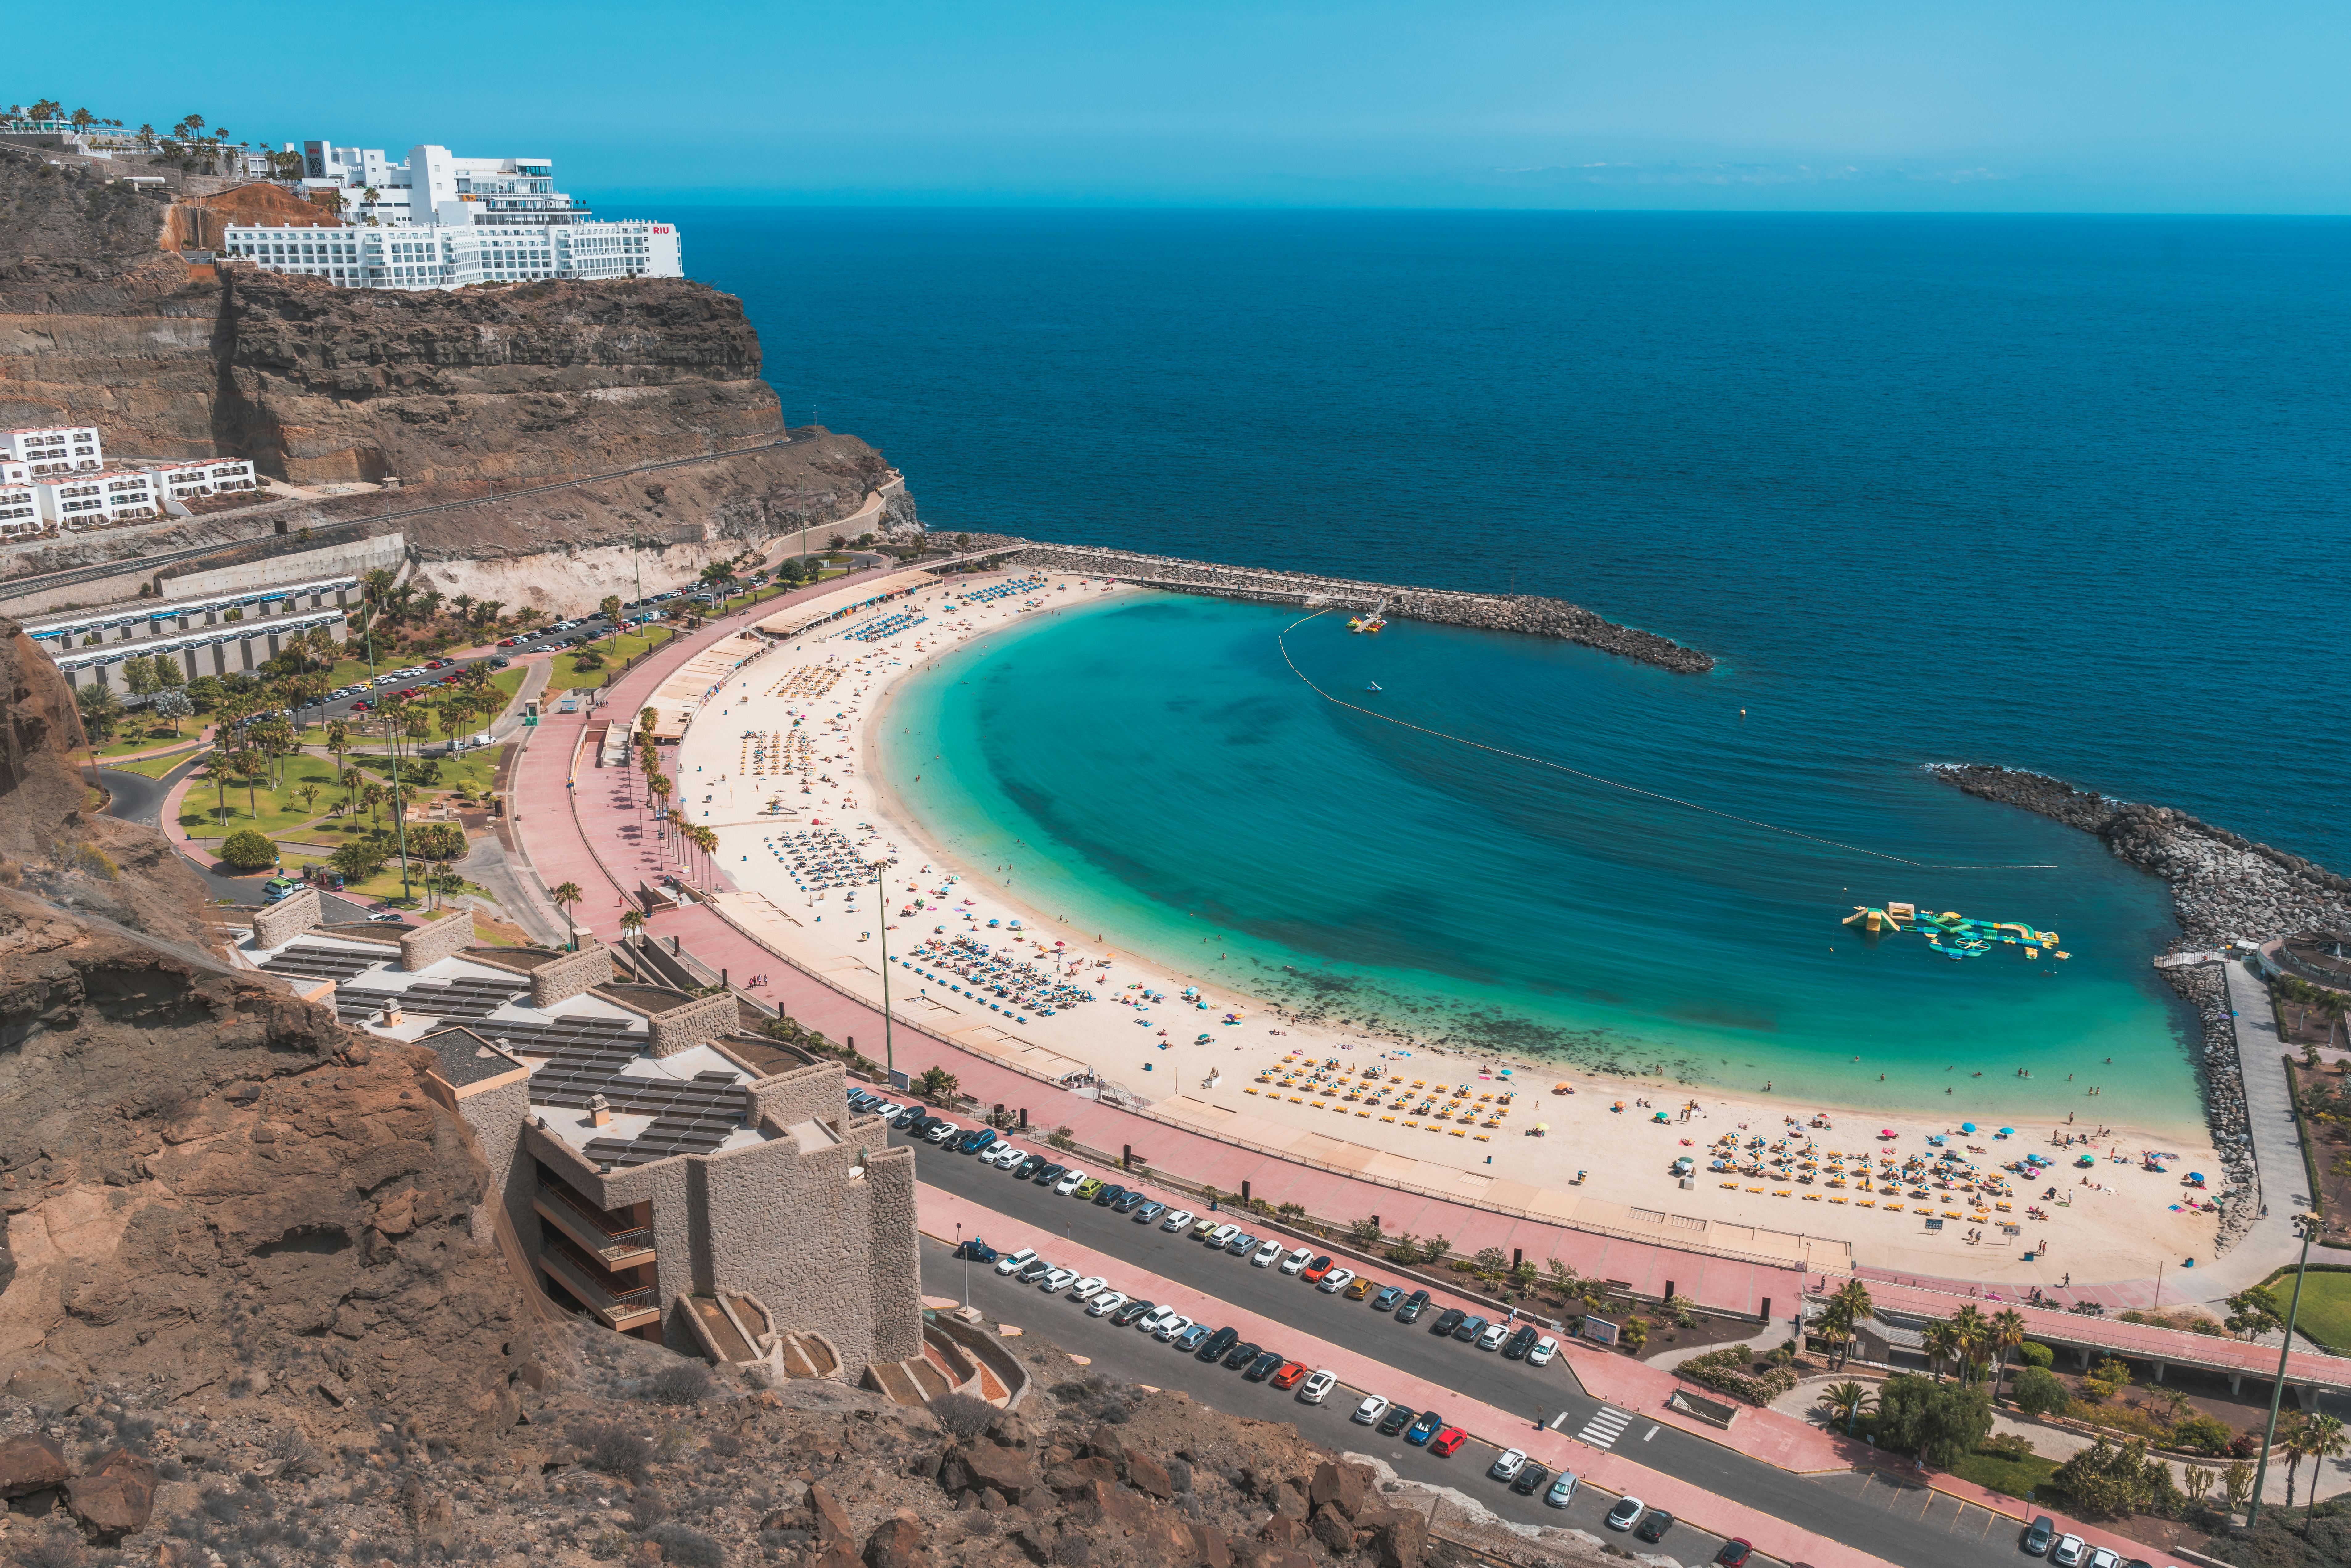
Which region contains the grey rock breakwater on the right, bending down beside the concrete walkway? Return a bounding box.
[1935,764,2351,1251]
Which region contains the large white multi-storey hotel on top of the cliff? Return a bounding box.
[223,141,686,289]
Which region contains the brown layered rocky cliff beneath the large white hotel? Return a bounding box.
[0,148,912,602]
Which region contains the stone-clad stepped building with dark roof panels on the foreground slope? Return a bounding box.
[242,891,922,1377]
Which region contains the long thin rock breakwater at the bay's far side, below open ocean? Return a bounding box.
[1009,543,1714,675]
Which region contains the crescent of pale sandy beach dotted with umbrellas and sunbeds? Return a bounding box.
[675,576,2222,1300]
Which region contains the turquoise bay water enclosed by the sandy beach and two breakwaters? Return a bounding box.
[882,595,2201,1133]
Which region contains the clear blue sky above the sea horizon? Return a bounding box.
[23,0,2351,212]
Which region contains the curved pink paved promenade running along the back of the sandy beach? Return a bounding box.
[513,581,1803,1314]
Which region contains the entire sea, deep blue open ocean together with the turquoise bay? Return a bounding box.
[677,209,2351,1121]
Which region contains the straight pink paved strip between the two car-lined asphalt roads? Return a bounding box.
[917,1185,1883,1568]
